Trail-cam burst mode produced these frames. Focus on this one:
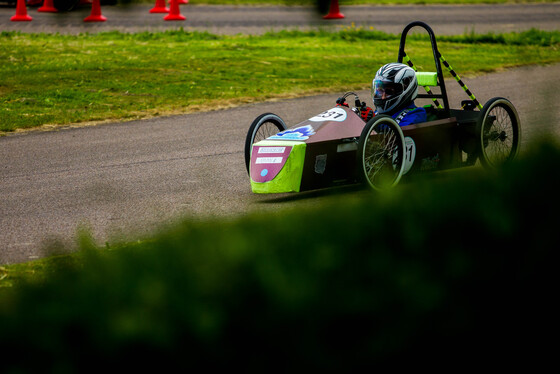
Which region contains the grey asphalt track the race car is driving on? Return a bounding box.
[0,7,560,264]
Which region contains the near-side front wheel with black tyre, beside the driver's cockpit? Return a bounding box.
[357,115,404,191]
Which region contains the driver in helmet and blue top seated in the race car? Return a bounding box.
[362,62,426,127]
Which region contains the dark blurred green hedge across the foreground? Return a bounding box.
[0,144,560,373]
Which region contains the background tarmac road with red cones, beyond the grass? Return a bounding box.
[0,0,560,35]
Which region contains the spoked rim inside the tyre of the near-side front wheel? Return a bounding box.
[362,126,403,190]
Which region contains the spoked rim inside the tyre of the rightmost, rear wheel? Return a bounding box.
[481,104,517,166]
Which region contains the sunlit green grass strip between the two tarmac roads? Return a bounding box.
[0,28,560,132]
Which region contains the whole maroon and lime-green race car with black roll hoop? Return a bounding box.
[245,22,520,193]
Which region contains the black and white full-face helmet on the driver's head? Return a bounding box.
[371,62,418,114]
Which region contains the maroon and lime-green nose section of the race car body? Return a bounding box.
[249,107,364,193]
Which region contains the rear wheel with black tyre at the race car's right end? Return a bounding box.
[476,97,521,169]
